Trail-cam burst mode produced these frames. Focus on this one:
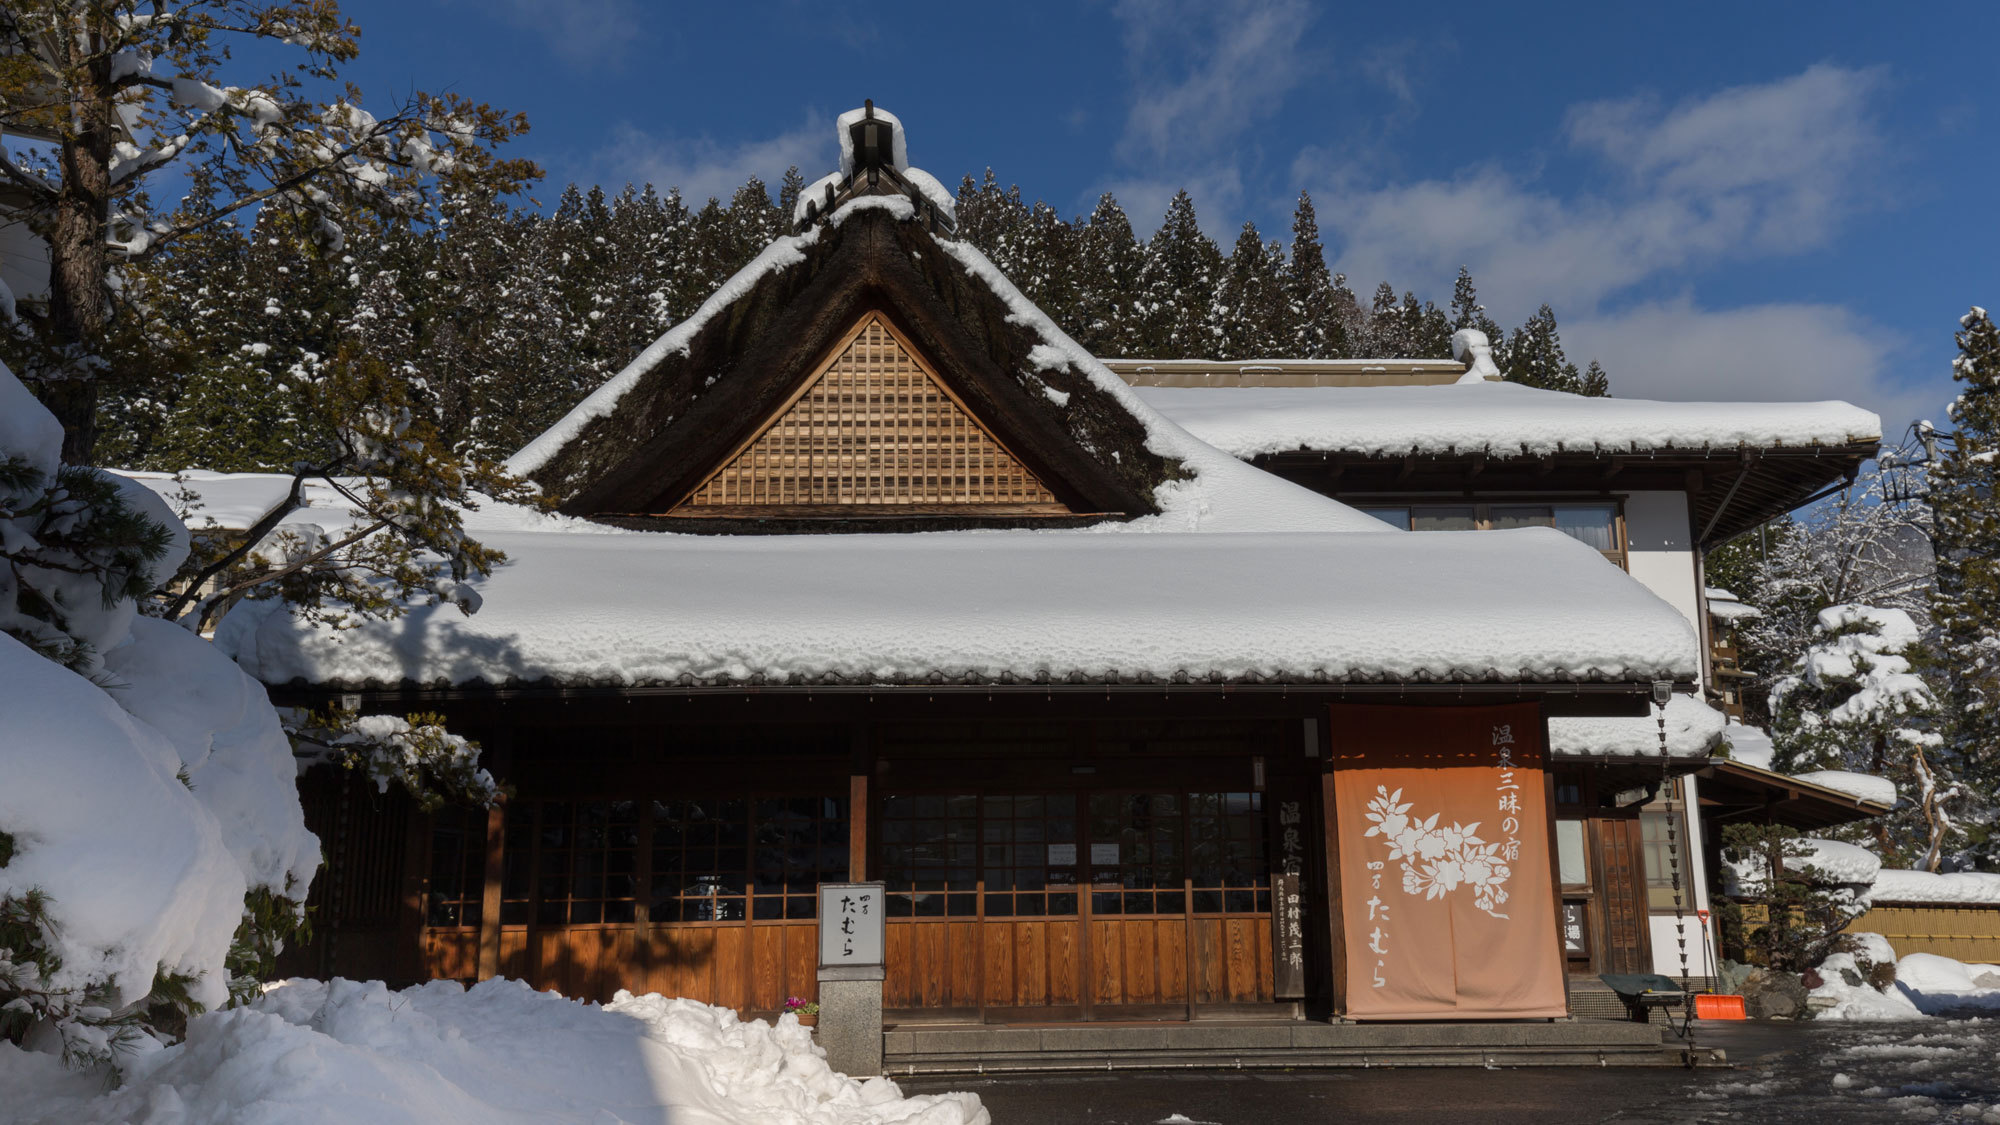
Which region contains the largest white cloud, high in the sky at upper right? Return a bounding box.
[1300,64,1886,320]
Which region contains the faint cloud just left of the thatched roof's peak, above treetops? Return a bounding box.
[594,112,840,208]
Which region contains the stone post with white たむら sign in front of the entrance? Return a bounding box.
[820,883,888,1079]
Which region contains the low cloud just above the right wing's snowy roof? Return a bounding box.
[1562,296,1950,426]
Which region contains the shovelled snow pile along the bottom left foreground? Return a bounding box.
[0,979,990,1125]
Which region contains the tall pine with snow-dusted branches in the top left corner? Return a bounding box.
[0,0,540,464]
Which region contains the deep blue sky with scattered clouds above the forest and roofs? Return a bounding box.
[332,0,2000,436]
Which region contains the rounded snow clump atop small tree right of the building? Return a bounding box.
[1770,605,1932,725]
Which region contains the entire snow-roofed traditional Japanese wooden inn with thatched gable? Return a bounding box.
[218,108,1880,1048]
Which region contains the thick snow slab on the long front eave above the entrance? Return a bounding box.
[216,528,1696,685]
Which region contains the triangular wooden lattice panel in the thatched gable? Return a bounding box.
[668,312,1072,518]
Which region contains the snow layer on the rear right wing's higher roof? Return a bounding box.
[1138,380,1882,458]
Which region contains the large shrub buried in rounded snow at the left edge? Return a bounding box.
[0,358,318,1059]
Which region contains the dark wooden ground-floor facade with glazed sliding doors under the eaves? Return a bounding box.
[286,693,1644,1023]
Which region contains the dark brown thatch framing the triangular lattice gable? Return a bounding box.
[530,208,1186,530]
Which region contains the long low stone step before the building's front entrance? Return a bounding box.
[882,1019,1722,1077]
